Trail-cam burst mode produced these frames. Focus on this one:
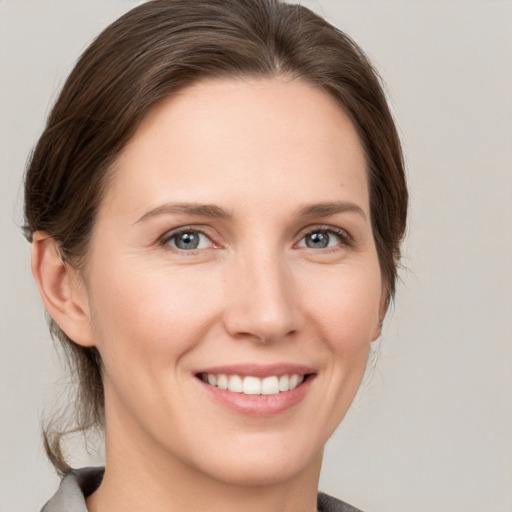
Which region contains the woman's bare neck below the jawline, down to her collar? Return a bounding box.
[87,416,322,512]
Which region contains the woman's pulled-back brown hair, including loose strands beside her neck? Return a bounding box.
[25,0,407,472]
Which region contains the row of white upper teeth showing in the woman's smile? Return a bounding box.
[200,373,304,395]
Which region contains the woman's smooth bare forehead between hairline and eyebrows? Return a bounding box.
[104,79,369,220]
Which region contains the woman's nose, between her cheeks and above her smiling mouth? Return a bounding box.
[224,249,300,343]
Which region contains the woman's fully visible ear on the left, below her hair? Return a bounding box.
[32,231,94,346]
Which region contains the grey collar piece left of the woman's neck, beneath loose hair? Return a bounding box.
[41,467,104,512]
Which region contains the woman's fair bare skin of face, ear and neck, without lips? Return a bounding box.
[33,79,386,512]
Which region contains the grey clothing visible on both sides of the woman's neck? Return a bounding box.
[41,467,362,512]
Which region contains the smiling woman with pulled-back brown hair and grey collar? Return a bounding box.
[25,0,407,512]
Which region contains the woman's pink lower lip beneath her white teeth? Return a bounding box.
[197,375,314,416]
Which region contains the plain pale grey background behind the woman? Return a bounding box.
[0,0,512,512]
